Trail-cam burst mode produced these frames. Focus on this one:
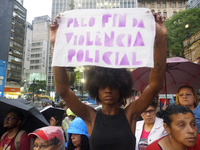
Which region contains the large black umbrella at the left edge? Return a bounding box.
[0,98,49,133]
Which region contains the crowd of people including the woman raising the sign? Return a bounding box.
[0,11,200,150]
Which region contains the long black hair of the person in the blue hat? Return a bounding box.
[67,134,90,150]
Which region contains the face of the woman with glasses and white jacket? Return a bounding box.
[141,106,156,124]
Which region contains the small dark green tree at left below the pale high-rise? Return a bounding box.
[29,80,46,94]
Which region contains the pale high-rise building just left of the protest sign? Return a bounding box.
[25,15,50,82]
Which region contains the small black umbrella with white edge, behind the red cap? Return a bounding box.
[40,106,66,121]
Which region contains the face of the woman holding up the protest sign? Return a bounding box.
[98,86,119,105]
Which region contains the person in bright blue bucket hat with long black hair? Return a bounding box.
[66,117,90,150]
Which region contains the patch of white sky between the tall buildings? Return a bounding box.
[23,0,52,23]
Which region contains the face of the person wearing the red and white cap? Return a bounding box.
[33,137,60,150]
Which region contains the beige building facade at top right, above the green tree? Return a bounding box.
[138,0,187,18]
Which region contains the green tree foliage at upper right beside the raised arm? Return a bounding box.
[165,8,200,56]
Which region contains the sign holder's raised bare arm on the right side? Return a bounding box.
[126,11,167,119]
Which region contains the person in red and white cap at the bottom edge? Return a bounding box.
[28,126,65,150]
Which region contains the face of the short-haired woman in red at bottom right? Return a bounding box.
[166,113,198,147]
